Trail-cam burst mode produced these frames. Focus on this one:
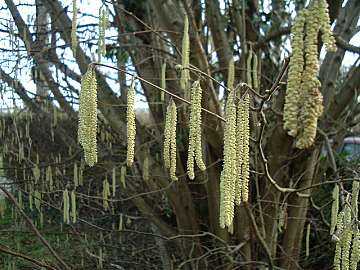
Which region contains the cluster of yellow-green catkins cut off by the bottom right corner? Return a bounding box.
[330,181,360,270]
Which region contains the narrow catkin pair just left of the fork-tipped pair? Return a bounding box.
[164,100,177,181]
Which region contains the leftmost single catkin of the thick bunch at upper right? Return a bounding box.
[284,10,307,136]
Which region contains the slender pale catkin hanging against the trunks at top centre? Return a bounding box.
[180,16,190,99]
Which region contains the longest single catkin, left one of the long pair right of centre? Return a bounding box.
[220,91,237,228]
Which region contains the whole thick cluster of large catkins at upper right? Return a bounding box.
[284,0,336,149]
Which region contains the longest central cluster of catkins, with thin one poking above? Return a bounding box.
[220,61,250,228]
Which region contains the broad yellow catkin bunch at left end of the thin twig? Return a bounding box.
[78,66,97,166]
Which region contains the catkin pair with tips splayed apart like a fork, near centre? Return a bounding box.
[187,80,206,180]
